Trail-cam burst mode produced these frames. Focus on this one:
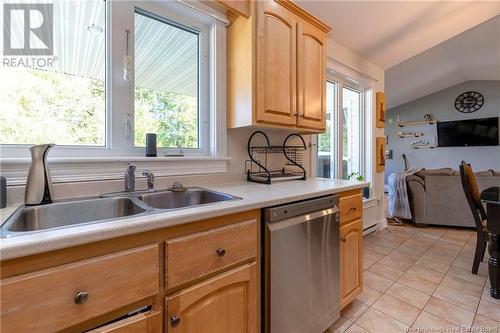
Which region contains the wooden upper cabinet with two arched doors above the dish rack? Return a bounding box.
[227,0,330,133]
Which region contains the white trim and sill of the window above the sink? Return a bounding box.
[0,1,230,185]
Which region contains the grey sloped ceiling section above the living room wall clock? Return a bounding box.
[385,16,500,108]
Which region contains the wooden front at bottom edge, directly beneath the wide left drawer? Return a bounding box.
[87,311,162,333]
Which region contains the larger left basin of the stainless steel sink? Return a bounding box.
[1,198,147,237]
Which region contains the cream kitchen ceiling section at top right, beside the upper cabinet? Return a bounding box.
[296,0,500,69]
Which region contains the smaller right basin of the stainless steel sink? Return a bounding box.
[137,187,238,209]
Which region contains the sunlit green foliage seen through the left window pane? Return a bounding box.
[0,67,106,146]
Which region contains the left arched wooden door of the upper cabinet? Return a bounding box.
[255,0,297,126]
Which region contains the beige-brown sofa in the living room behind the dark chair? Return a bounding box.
[406,168,500,228]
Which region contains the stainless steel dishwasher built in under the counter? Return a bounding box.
[263,195,340,333]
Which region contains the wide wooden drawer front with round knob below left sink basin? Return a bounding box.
[0,244,159,333]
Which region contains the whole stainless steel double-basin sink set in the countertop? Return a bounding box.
[0,187,239,238]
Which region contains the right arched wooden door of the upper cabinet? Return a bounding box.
[297,22,326,130]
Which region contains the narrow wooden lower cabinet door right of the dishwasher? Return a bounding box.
[340,220,363,308]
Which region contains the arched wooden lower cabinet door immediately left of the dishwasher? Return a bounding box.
[165,263,259,333]
